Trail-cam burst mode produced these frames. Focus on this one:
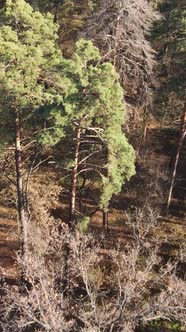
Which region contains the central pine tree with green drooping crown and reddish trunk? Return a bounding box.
[41,40,135,222]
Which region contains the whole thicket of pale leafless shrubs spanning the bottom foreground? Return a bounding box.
[1,211,186,332]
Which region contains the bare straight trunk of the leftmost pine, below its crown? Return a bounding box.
[15,113,27,256]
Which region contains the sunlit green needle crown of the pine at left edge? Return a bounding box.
[0,0,61,126]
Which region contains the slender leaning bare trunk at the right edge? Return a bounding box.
[167,102,186,211]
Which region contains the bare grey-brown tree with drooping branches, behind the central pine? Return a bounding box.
[83,0,159,126]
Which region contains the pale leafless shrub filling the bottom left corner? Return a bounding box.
[2,248,72,332]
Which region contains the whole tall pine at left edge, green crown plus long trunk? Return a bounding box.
[0,0,61,253]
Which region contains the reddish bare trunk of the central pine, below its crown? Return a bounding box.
[69,124,81,227]
